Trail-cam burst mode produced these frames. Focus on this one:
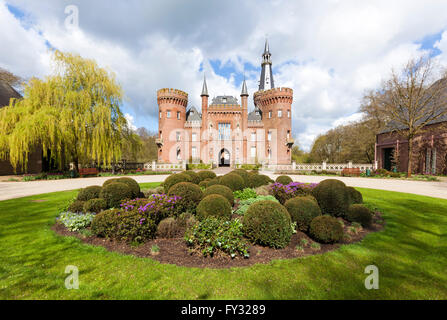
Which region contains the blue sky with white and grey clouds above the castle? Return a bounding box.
[0,0,447,149]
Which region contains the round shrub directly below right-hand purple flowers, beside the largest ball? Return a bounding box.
[284,197,321,232]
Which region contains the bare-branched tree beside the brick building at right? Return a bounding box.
[364,56,447,176]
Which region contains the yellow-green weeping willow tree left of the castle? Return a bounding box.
[0,51,135,169]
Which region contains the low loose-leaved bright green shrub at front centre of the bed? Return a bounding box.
[185,218,249,258]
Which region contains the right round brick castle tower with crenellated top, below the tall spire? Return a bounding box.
[253,88,294,164]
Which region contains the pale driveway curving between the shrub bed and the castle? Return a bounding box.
[0,169,447,201]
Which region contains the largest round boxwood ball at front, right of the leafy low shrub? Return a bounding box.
[242,200,292,248]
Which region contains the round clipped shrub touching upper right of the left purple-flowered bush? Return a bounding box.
[168,182,203,213]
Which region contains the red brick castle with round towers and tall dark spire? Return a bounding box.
[156,41,294,166]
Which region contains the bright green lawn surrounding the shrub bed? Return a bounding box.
[0,184,447,299]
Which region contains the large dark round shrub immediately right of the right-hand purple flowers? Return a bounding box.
[312,179,350,217]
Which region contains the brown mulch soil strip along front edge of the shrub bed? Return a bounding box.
[52,212,383,269]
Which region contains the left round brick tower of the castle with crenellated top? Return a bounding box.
[156,88,188,163]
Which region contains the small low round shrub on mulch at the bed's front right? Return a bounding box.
[309,216,343,243]
